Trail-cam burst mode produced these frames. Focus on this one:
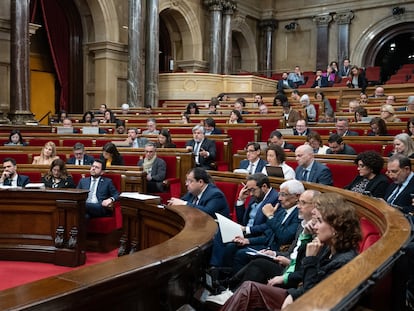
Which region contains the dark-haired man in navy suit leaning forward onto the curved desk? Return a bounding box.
[168,167,230,218]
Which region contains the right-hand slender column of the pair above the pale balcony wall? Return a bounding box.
[223,0,236,75]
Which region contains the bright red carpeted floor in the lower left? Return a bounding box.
[0,249,118,290]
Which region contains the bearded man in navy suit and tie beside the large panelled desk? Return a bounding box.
[77,159,119,218]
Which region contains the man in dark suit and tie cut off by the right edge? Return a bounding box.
[385,153,414,213]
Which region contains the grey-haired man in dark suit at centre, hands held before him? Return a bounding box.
[185,125,216,170]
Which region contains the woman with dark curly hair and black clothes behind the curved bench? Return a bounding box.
[345,151,389,198]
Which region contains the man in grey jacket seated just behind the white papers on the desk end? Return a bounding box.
[137,142,167,193]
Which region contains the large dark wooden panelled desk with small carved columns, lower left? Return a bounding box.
[0,189,88,267]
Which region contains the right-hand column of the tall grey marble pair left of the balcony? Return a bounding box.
[144,0,160,107]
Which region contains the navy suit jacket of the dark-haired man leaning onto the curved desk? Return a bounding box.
[181,184,230,218]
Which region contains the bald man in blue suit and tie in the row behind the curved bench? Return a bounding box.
[295,145,333,186]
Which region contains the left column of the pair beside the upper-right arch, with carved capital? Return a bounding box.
[313,14,332,70]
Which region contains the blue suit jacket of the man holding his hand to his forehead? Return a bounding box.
[235,188,279,235]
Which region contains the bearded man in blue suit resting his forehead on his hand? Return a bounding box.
[210,173,278,267]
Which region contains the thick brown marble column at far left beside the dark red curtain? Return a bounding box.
[9,0,36,124]
